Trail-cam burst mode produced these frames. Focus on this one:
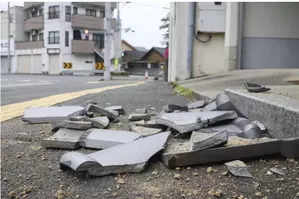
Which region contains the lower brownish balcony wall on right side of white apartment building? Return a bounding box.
[72,40,95,54]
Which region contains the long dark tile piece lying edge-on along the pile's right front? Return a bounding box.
[162,137,282,168]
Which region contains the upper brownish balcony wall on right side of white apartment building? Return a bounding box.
[72,15,104,30]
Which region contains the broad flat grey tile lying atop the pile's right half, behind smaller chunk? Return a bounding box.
[156,111,237,134]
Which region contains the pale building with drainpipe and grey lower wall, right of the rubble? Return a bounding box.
[168,2,299,81]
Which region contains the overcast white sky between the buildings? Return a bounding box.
[0,1,169,48]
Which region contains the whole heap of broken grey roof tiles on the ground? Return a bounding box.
[23,94,276,176]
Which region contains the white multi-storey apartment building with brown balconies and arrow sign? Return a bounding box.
[12,2,116,74]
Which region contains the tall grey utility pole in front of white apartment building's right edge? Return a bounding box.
[104,2,113,80]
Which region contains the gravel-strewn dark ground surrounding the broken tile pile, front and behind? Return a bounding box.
[1,83,299,199]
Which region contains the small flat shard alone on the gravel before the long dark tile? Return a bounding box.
[225,160,253,178]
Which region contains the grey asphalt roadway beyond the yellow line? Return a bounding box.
[1,75,143,105]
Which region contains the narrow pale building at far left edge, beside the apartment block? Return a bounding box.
[0,6,24,73]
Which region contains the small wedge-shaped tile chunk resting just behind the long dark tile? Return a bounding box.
[190,131,228,151]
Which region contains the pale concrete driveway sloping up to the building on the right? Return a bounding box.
[178,69,299,99]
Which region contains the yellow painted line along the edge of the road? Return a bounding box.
[0,81,144,122]
